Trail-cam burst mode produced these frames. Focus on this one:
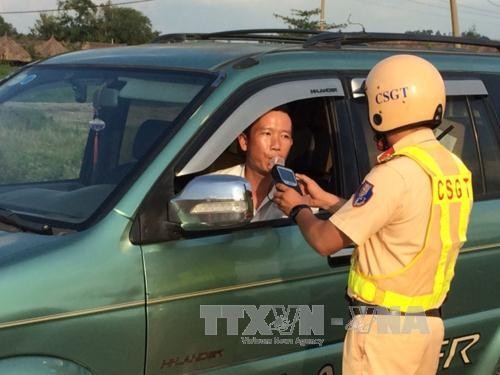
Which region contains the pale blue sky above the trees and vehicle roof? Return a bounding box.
[0,0,500,39]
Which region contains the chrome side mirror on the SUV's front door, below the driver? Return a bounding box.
[168,175,253,231]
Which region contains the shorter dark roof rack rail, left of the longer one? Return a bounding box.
[152,29,322,43]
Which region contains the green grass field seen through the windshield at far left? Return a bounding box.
[0,103,88,184]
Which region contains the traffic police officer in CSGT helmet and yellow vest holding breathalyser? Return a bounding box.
[274,55,473,374]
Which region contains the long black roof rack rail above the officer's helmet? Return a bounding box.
[303,31,500,51]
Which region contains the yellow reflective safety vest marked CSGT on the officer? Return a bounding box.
[348,142,473,312]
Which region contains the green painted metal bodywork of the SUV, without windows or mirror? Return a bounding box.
[0,33,500,375]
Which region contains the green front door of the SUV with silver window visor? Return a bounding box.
[142,75,357,374]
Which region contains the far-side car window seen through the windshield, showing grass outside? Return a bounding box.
[0,80,89,184]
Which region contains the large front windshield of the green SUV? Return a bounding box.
[0,66,214,226]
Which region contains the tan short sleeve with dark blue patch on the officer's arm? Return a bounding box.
[330,162,406,245]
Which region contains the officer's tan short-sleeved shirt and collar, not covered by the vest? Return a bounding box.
[330,129,437,275]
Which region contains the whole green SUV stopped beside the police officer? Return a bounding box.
[0,30,500,375]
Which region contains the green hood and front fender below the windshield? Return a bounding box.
[0,211,146,373]
